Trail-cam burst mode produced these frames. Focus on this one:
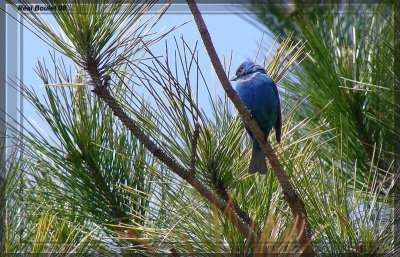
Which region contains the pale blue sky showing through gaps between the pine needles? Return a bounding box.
[19,4,272,137]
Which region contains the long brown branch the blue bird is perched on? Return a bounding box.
[186,0,314,253]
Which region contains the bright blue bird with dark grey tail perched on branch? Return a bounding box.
[231,61,282,174]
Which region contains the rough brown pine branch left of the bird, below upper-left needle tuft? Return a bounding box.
[85,63,256,242]
